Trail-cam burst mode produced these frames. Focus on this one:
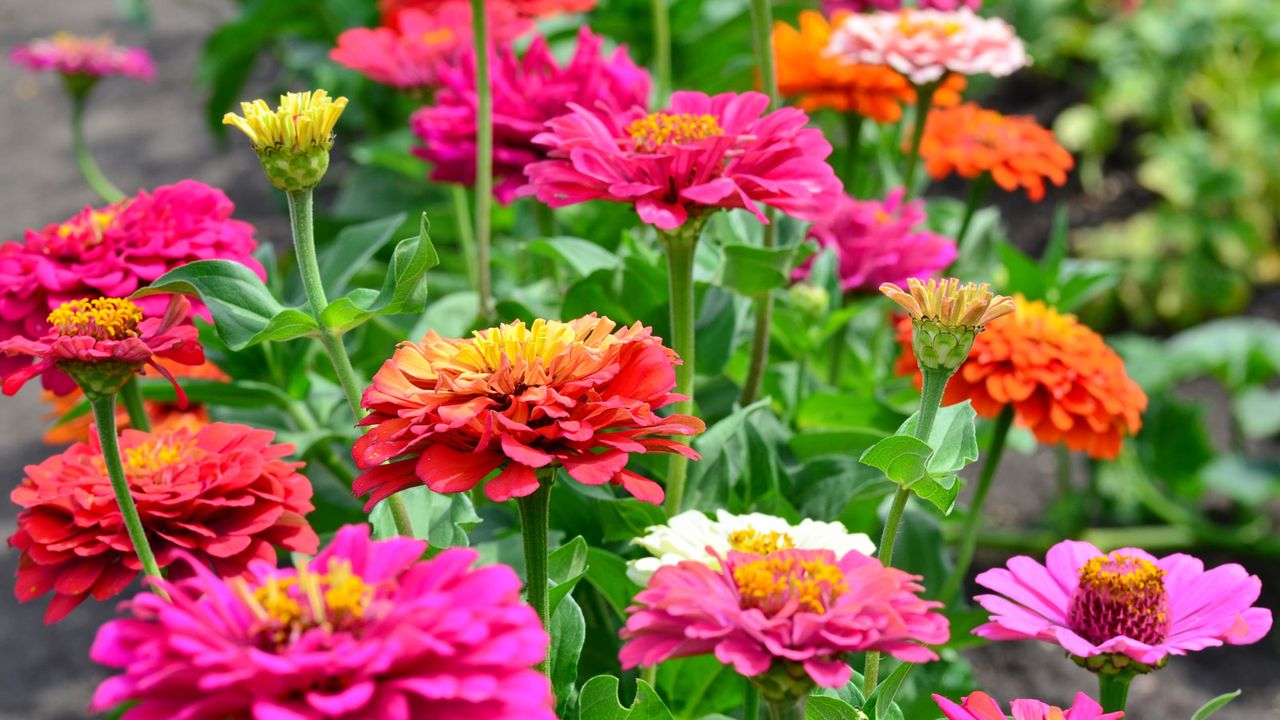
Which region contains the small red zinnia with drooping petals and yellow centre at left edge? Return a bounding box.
[0,295,205,397]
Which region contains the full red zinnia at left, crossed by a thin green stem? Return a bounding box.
[9,423,319,623]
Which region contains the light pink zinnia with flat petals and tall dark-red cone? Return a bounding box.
[974,541,1271,671]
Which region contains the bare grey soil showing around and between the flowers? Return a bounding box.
[0,0,1280,720]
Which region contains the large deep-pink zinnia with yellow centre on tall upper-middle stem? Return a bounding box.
[525,92,841,231]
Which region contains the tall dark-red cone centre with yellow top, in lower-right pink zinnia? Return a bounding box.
[1068,553,1169,644]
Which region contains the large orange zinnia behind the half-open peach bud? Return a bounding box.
[895,296,1147,460]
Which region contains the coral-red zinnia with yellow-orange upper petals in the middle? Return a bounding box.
[353,314,704,507]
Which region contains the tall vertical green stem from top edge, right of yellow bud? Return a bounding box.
[471,0,493,318]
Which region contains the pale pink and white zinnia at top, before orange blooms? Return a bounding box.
[827,8,1030,85]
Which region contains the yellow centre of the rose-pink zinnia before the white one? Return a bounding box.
[733,555,849,607]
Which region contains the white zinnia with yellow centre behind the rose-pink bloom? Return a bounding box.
[627,510,876,585]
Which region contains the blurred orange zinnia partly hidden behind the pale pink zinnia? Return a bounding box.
[773,10,965,123]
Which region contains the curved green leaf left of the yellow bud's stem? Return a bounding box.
[132,260,319,351]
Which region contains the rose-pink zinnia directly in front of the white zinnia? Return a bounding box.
[618,550,951,689]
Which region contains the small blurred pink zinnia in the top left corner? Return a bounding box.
[9,32,156,82]
